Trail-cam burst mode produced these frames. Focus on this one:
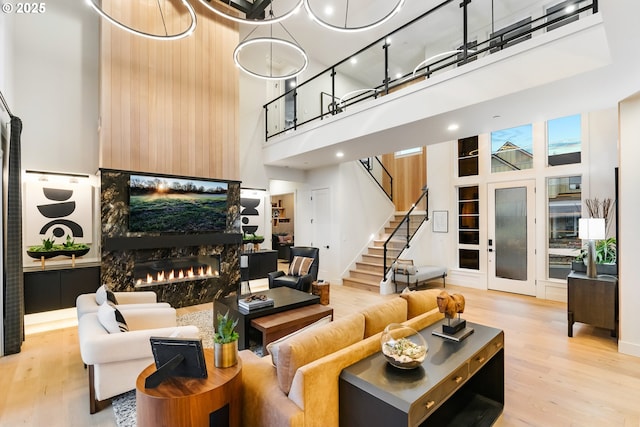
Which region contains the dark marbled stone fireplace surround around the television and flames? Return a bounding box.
[100,169,242,308]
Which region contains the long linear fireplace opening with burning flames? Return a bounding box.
[133,255,220,288]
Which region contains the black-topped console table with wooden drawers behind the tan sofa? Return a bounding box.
[340,321,504,427]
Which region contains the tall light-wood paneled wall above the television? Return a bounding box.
[99,0,240,180]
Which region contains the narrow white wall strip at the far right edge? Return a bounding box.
[618,93,640,357]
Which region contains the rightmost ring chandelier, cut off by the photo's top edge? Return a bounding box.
[304,0,405,33]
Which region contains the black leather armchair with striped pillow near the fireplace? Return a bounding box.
[269,246,320,292]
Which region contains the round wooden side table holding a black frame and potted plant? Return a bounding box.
[136,348,242,427]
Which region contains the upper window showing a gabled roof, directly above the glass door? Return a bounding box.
[491,124,533,173]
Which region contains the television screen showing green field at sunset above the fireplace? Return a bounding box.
[129,175,228,233]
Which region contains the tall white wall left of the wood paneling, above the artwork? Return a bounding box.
[8,0,100,174]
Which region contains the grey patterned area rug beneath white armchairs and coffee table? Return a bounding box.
[111,310,262,427]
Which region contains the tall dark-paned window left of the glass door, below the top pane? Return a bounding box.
[458,185,480,270]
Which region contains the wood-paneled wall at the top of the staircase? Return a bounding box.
[382,147,427,212]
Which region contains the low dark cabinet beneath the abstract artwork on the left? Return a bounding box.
[24,266,100,314]
